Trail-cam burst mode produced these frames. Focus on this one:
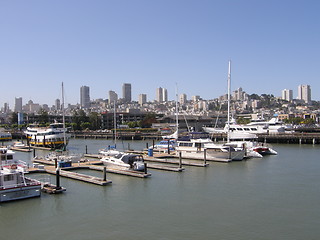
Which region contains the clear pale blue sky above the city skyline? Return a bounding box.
[0,0,320,108]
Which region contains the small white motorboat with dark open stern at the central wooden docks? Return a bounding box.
[101,153,145,171]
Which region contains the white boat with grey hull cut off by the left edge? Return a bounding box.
[0,148,41,202]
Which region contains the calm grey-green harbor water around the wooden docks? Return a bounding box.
[0,139,320,240]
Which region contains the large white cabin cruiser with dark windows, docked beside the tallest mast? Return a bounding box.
[176,132,245,162]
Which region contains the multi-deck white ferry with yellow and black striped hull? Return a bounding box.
[24,123,71,149]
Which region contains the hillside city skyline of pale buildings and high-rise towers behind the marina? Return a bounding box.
[0,83,319,127]
